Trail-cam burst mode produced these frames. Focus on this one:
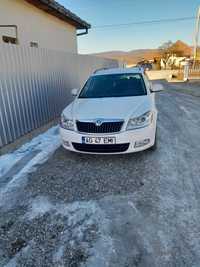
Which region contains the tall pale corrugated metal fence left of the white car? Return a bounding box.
[0,45,118,147]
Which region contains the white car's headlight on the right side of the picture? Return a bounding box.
[126,111,153,130]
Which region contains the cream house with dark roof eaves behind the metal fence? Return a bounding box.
[0,0,90,53]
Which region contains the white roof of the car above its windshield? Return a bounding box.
[92,67,144,76]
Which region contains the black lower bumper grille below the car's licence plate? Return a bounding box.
[72,143,129,153]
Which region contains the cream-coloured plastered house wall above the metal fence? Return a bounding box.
[0,0,77,53]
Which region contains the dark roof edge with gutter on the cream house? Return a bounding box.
[26,0,91,29]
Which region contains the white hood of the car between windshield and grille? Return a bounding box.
[64,95,151,120]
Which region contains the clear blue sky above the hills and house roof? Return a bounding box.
[57,0,200,54]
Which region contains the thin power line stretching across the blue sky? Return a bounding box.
[92,16,196,29]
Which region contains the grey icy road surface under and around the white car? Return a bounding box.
[0,84,200,267]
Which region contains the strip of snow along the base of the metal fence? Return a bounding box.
[0,126,61,210]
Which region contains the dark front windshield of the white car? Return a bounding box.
[79,74,147,98]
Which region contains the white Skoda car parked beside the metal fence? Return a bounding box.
[60,68,162,154]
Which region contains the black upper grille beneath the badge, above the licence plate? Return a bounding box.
[76,121,123,133]
